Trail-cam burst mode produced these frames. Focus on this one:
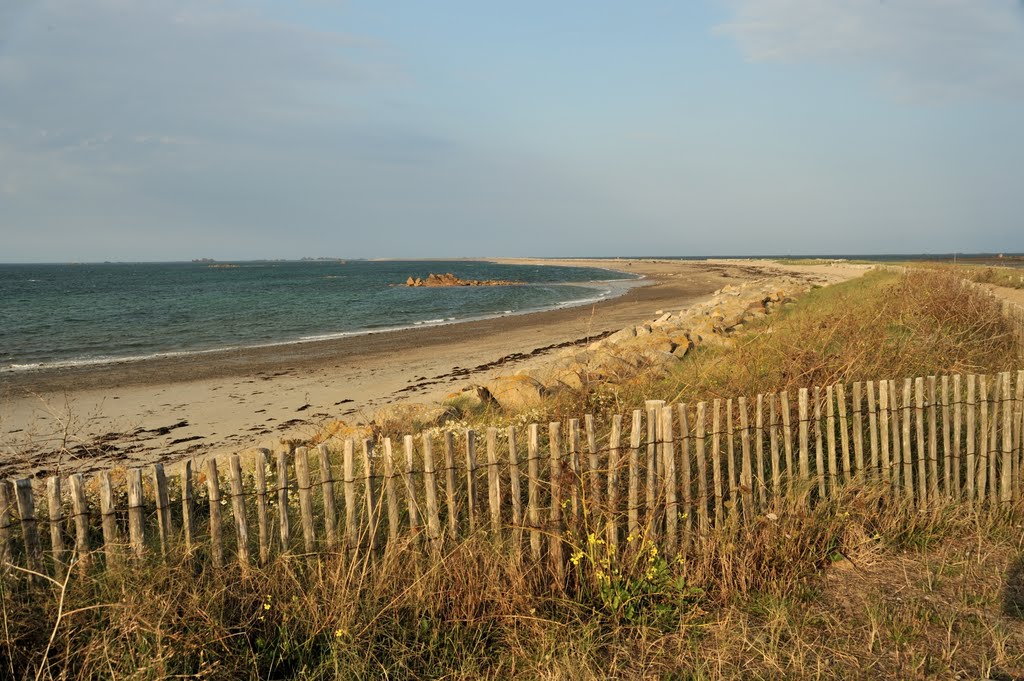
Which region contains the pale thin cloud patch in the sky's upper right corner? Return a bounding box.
[717,0,1024,97]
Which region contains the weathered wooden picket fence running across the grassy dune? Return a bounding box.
[0,371,1024,580]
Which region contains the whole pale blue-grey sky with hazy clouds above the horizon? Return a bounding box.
[0,0,1024,262]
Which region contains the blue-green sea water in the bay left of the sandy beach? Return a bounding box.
[0,260,628,372]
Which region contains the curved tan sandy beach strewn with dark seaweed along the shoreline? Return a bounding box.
[0,259,863,475]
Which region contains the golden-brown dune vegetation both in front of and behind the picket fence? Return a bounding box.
[0,271,1024,680]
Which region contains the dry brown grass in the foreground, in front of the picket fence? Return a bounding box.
[6,484,1024,679]
